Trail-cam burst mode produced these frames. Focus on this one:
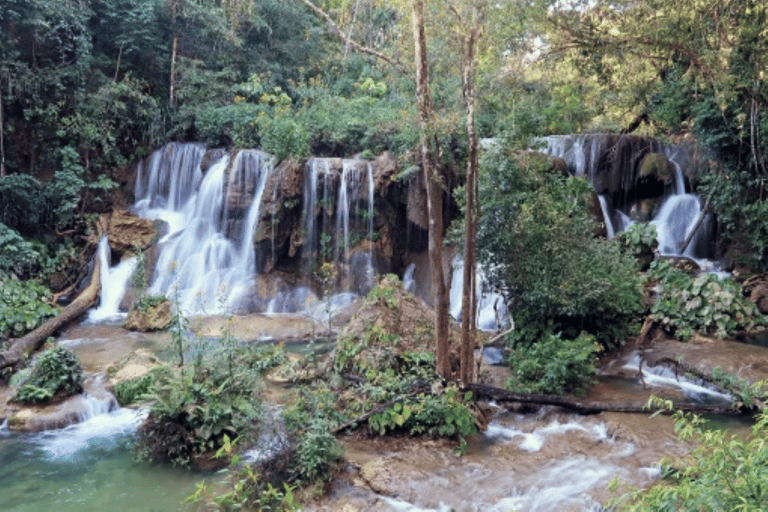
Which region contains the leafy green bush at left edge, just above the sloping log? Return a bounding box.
[0,279,56,337]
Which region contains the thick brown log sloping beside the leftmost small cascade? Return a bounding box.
[0,258,101,368]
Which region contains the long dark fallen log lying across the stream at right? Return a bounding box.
[462,384,735,414]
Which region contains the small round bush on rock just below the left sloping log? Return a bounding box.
[13,347,83,404]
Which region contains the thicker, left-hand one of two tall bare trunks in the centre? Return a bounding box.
[411,0,451,379]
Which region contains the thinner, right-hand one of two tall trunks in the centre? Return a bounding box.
[459,2,484,383]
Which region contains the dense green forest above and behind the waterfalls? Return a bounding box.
[0,0,768,308]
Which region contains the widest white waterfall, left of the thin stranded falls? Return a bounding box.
[135,145,272,314]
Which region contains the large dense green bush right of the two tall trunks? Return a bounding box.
[477,147,643,347]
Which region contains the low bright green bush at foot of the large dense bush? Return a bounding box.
[507,334,599,395]
